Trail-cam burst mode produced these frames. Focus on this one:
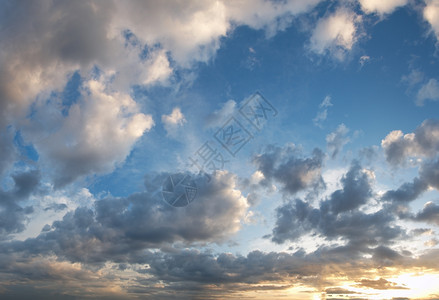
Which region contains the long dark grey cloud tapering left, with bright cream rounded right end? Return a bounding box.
[7,172,248,263]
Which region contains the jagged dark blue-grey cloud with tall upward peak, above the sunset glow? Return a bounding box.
[272,161,405,246]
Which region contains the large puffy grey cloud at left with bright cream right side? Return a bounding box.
[23,79,154,186]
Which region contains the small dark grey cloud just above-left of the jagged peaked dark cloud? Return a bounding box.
[253,145,324,195]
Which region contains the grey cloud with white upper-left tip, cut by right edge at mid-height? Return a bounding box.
[381,120,439,166]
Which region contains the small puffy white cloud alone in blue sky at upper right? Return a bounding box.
[309,8,360,60]
